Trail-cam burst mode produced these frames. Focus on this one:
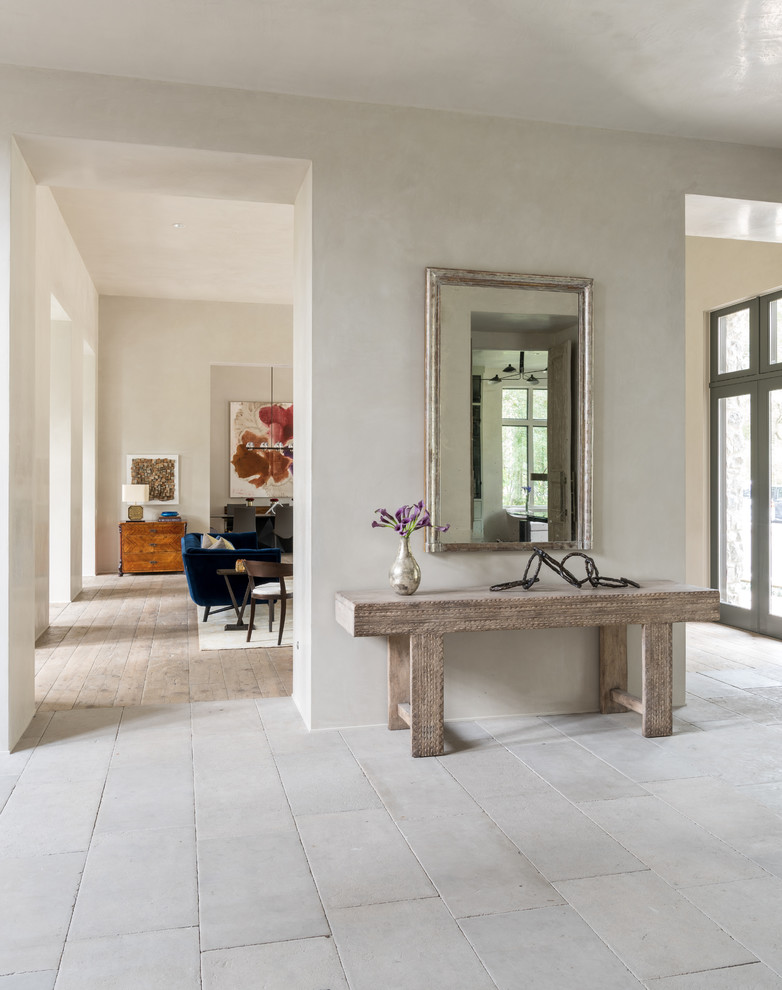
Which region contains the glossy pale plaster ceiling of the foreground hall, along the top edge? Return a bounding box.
[0,0,782,147]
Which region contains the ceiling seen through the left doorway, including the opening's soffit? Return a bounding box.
[17,136,309,305]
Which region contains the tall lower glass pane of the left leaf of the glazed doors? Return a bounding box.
[718,395,752,608]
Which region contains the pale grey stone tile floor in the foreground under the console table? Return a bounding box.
[0,626,782,990]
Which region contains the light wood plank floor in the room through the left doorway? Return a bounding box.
[35,574,293,711]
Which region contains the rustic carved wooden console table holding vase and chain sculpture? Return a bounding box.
[336,581,719,756]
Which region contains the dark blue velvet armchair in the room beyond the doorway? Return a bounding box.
[182,533,282,622]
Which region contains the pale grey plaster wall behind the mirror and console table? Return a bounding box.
[0,67,782,735]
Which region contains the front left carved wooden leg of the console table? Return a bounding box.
[410,633,444,756]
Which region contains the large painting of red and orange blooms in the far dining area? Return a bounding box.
[229,402,293,498]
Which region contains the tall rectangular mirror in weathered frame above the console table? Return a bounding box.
[426,268,592,552]
